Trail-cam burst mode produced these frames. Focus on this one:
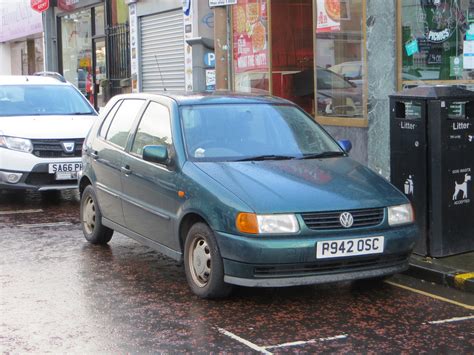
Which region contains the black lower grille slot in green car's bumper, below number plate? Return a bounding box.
[254,255,408,278]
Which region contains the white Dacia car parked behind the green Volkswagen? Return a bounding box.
[0,76,97,191]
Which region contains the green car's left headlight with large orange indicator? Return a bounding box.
[235,213,300,234]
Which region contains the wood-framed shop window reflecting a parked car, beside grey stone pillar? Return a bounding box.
[316,0,367,127]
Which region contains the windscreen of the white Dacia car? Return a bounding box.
[0,85,95,116]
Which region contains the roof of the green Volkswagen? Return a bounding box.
[116,91,294,106]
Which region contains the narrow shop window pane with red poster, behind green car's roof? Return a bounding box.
[232,0,271,92]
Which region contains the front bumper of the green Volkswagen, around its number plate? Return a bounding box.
[216,225,418,287]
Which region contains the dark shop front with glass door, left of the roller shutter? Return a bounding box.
[56,0,130,108]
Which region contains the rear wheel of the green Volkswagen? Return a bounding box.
[81,185,114,245]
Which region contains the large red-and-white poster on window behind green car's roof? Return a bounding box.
[232,0,269,73]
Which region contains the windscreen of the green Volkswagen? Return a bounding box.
[181,104,343,161]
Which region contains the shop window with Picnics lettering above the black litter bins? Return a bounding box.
[399,0,474,86]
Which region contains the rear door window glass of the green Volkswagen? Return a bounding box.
[105,99,145,148]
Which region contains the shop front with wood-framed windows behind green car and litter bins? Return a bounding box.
[230,0,474,167]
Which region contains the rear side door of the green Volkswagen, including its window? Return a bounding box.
[89,99,145,225]
